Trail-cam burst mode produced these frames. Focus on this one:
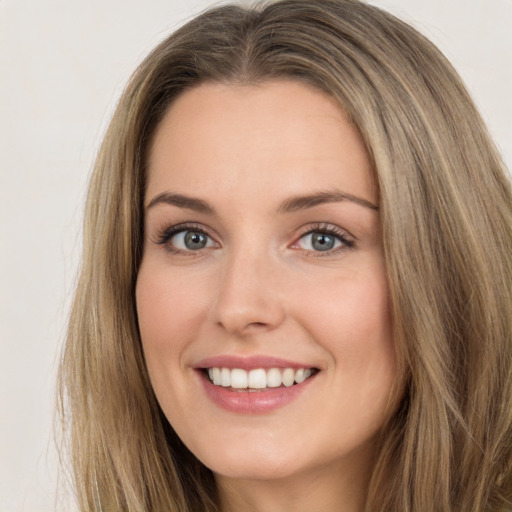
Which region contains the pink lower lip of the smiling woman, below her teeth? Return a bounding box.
[200,372,316,414]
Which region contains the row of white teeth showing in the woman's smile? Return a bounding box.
[202,366,319,392]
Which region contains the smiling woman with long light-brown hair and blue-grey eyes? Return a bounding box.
[61,0,512,512]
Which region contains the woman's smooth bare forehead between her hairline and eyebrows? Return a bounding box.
[147,80,377,206]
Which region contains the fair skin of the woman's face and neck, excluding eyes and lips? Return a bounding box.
[136,81,396,512]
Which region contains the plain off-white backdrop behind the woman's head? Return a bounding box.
[0,0,512,512]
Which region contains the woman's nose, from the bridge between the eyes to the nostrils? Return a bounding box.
[210,250,285,337]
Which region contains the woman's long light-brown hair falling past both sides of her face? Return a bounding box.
[59,0,512,512]
